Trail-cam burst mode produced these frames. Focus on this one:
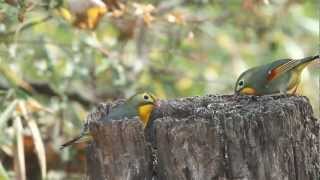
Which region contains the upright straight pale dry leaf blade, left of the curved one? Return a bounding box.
[13,116,27,180]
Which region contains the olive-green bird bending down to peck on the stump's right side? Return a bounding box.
[235,55,319,95]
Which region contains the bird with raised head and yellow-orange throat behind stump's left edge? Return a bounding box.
[61,93,157,149]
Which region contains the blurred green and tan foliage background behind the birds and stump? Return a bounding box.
[0,0,320,180]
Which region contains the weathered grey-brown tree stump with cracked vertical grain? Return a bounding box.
[87,95,320,180]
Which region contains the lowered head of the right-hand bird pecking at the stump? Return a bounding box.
[234,69,256,95]
